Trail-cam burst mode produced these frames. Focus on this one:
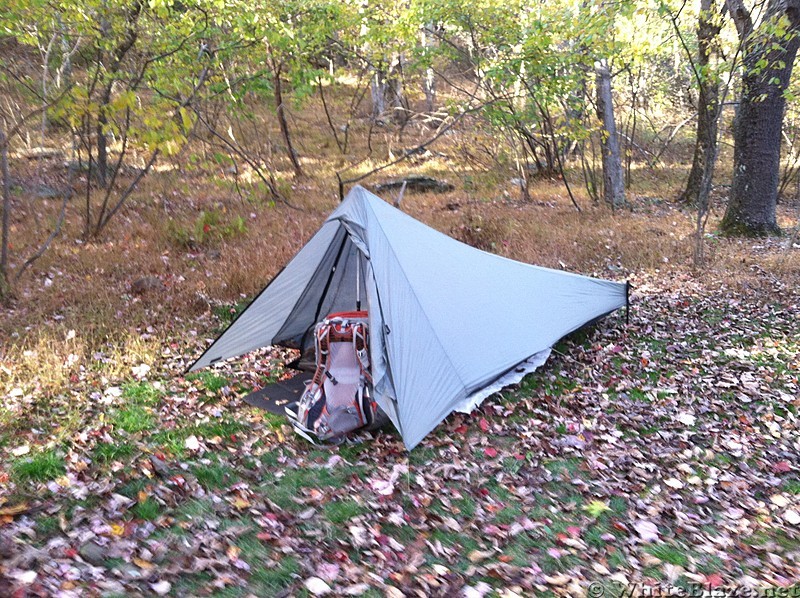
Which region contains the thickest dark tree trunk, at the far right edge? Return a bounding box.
[720,0,800,236]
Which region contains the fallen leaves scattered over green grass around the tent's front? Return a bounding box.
[0,273,800,596]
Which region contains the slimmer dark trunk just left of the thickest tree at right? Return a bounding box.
[681,0,721,205]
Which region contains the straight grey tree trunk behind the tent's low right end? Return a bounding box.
[595,61,626,209]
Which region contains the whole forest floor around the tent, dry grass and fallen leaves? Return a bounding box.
[0,105,800,597]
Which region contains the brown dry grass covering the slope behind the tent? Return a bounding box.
[0,83,800,408]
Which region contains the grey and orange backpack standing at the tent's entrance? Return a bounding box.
[286,311,379,444]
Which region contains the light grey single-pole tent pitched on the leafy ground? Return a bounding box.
[190,187,628,449]
